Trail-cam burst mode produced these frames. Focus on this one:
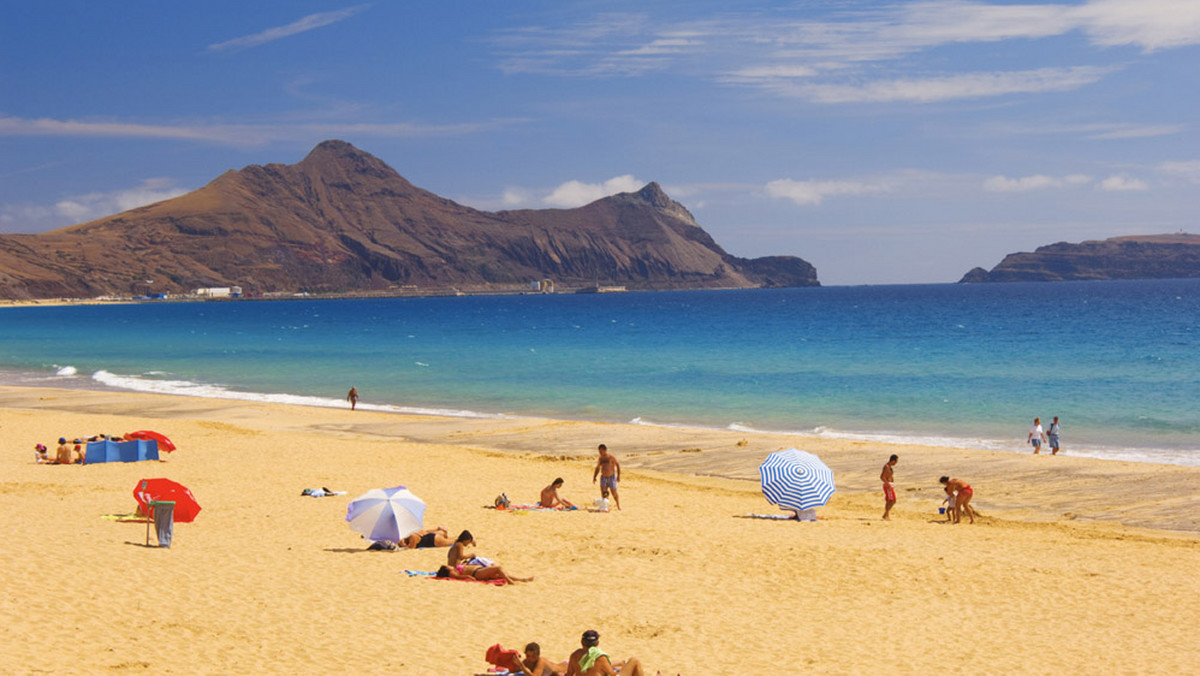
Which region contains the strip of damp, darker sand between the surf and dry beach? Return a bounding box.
[0,385,1200,533]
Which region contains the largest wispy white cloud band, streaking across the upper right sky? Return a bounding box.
[496,0,1200,106]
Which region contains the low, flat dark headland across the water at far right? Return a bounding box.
[959,233,1200,283]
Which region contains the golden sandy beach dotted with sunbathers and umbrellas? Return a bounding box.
[0,388,1200,675]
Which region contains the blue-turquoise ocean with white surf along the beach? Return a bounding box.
[0,280,1200,466]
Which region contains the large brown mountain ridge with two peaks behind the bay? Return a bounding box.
[0,140,818,298]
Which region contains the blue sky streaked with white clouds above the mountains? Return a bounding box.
[0,0,1200,285]
